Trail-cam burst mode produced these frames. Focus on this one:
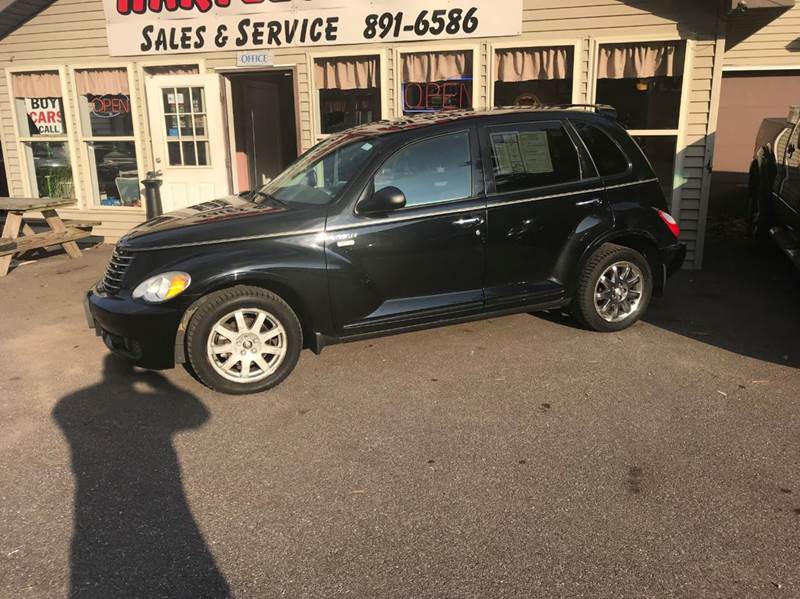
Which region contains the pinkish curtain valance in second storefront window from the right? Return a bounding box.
[495,48,572,83]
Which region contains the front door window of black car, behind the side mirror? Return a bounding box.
[374,131,472,208]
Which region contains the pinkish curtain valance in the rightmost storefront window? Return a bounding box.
[598,42,685,79]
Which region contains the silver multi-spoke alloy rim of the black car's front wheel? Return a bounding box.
[206,308,287,383]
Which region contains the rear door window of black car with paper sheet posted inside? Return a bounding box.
[487,122,581,193]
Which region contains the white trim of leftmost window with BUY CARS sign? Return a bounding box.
[5,64,83,206]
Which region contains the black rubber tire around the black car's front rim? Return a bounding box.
[186,286,303,395]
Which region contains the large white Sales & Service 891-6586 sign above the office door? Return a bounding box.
[103,0,522,56]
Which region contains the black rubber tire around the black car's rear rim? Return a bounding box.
[572,243,653,333]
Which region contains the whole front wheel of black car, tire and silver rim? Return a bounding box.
[186,286,303,395]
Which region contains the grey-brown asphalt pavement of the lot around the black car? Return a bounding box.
[0,237,800,599]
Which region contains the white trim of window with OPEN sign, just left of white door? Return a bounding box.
[68,62,147,213]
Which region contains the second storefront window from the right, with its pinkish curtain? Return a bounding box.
[494,47,574,107]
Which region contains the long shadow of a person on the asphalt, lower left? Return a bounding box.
[53,355,232,599]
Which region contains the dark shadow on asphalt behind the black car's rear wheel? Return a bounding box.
[537,239,800,368]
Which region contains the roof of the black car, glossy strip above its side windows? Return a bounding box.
[342,104,617,137]
